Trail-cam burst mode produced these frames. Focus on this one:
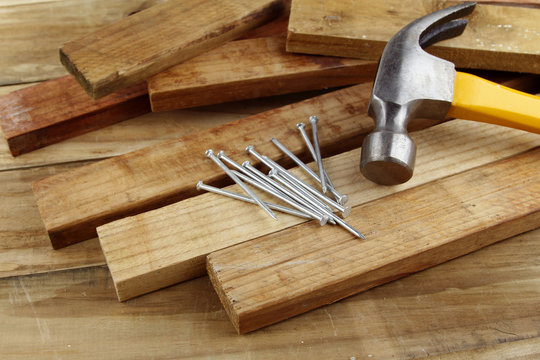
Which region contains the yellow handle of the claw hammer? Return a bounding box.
[448,72,540,134]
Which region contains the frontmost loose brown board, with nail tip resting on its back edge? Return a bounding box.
[207,148,540,333]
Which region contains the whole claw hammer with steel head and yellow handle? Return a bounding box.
[360,2,540,185]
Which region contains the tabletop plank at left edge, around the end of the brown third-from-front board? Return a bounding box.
[0,163,105,278]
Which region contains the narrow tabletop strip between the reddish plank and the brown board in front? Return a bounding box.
[0,88,316,171]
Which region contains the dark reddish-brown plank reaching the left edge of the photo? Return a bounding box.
[0,75,150,156]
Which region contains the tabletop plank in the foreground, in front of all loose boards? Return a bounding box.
[0,230,540,360]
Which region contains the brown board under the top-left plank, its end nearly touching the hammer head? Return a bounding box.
[148,37,377,111]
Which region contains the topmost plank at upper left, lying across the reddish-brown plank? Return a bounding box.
[60,0,283,99]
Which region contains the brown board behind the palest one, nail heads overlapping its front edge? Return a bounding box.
[34,84,418,248]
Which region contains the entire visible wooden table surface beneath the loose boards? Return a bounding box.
[0,0,540,359]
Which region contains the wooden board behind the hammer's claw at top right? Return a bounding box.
[287,0,540,74]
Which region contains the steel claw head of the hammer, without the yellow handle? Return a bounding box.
[360,2,476,185]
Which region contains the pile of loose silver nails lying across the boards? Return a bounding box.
[197,116,365,239]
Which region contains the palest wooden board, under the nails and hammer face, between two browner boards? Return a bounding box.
[97,120,540,301]
